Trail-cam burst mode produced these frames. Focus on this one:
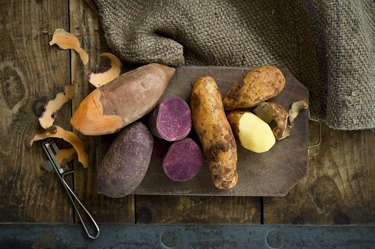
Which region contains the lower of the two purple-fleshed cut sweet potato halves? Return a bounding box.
[163,138,203,182]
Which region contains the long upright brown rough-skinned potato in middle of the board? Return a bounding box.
[190,76,238,189]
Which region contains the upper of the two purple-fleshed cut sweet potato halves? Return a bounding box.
[148,96,191,142]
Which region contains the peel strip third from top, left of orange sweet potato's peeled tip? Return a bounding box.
[39,85,75,129]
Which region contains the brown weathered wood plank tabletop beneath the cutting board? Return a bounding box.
[0,0,375,224]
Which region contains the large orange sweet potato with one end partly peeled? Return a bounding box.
[71,63,175,135]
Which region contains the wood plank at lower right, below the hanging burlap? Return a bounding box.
[264,125,375,224]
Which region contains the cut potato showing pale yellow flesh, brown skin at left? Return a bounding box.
[227,111,276,153]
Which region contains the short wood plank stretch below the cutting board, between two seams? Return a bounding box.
[136,195,261,224]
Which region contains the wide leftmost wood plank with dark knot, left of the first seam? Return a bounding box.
[0,0,73,222]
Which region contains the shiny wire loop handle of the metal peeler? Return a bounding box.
[60,175,100,239]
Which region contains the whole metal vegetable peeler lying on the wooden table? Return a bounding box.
[42,140,100,239]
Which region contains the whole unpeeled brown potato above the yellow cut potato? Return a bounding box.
[223,66,285,111]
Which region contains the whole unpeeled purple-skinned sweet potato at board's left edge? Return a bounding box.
[97,122,153,198]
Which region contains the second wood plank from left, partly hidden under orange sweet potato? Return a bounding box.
[69,0,135,223]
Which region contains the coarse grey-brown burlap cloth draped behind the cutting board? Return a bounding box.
[96,0,375,130]
